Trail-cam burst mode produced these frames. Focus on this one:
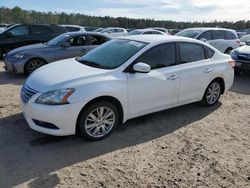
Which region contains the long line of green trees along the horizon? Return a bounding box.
[0,6,250,30]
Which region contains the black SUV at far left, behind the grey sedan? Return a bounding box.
[0,24,67,59]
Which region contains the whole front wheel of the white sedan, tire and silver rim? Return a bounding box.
[77,101,120,141]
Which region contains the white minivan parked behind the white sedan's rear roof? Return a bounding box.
[176,28,240,54]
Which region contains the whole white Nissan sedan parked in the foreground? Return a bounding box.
[21,35,234,140]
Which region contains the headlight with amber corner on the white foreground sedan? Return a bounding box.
[36,88,75,105]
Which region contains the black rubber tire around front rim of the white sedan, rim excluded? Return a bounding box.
[77,101,120,141]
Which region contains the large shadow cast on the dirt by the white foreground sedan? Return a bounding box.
[0,103,221,187]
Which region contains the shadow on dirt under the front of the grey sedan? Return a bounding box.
[0,71,26,85]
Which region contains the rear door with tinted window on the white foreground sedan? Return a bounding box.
[178,42,214,104]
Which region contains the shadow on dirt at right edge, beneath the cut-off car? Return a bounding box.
[230,73,250,95]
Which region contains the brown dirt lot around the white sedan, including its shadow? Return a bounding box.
[0,62,250,188]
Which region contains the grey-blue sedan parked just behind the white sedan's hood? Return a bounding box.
[4,32,111,75]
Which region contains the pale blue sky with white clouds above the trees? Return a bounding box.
[0,0,250,21]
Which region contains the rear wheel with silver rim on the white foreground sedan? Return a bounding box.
[201,80,222,106]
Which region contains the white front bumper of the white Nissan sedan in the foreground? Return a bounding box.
[20,93,86,136]
